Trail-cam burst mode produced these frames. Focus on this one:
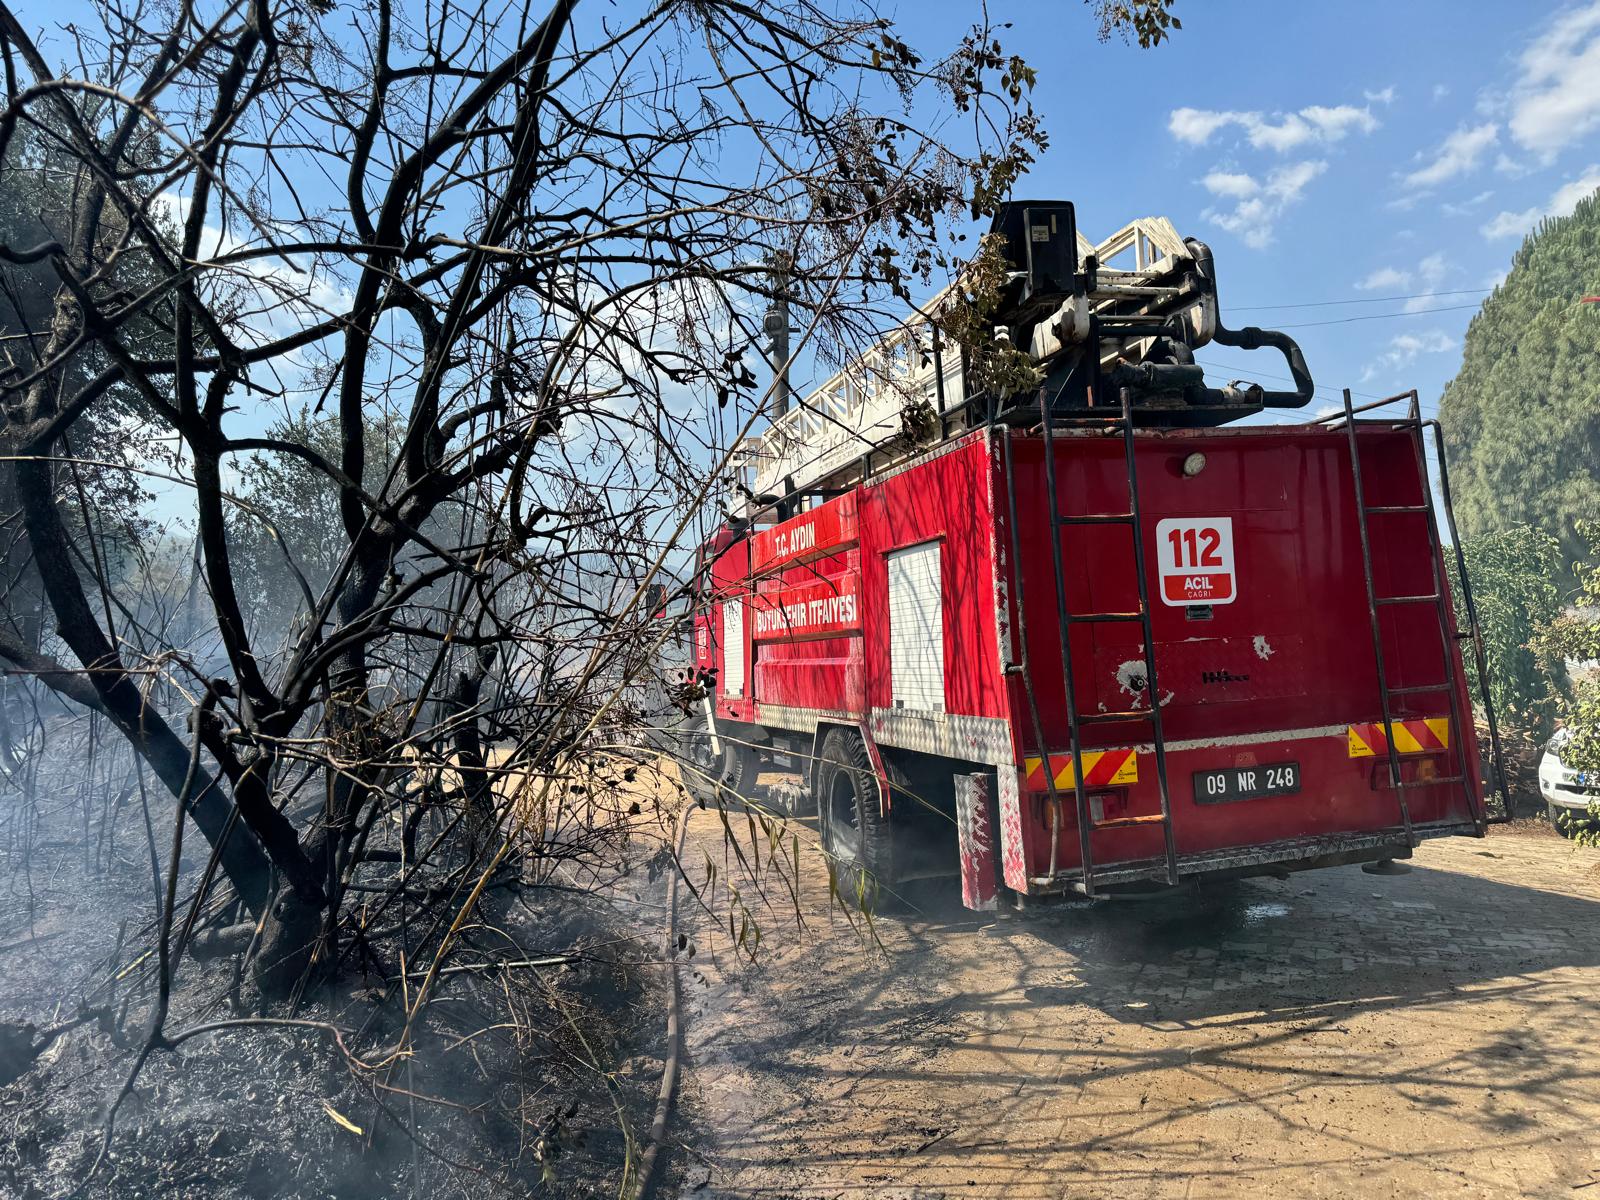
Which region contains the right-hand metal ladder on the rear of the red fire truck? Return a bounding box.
[1344,387,1509,846]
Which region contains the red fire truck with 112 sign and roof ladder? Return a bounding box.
[690,202,1498,909]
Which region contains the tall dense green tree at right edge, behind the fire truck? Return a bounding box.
[1438,197,1600,563]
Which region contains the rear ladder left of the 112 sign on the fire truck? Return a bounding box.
[1029,389,1178,896]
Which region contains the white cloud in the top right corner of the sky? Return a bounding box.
[1507,0,1600,162]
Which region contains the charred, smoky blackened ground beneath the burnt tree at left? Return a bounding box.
[0,797,681,1200]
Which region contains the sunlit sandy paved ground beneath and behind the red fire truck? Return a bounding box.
[668,816,1600,1200]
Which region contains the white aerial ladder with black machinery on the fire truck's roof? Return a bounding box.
[734,202,1312,515]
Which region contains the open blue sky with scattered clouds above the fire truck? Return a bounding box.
[890,0,1600,422]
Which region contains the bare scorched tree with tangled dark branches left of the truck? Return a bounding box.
[0,0,1049,1004]
